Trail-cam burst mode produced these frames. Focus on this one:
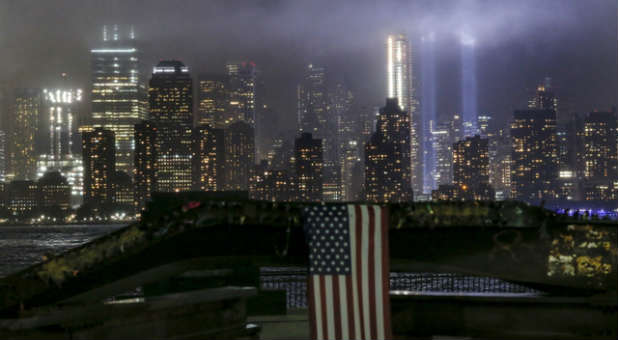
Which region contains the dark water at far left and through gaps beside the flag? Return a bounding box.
[0,225,539,309]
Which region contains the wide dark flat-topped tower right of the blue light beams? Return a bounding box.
[511,109,558,202]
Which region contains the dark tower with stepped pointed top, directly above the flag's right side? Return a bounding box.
[365,98,413,202]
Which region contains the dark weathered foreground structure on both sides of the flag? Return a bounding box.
[0,193,618,339]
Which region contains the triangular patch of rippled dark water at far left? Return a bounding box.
[0,225,124,277]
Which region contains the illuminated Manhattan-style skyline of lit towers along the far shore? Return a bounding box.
[0,1,618,222]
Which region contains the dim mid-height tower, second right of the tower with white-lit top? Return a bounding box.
[224,121,255,191]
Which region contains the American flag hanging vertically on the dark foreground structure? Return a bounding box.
[303,204,392,339]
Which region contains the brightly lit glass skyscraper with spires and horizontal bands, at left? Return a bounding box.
[90,25,147,176]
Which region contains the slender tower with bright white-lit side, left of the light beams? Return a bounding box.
[386,34,423,197]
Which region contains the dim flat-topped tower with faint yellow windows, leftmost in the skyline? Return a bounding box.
[7,89,42,180]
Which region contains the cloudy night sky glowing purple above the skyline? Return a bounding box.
[0,0,618,130]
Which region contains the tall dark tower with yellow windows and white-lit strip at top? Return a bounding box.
[135,60,193,198]
